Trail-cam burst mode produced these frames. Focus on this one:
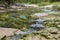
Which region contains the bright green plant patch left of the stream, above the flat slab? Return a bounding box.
[0,14,29,29]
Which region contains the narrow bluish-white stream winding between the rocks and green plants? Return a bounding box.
[2,4,59,40]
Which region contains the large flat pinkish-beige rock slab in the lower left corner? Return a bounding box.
[0,27,18,39]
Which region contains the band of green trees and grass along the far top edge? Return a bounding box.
[0,0,60,6]
